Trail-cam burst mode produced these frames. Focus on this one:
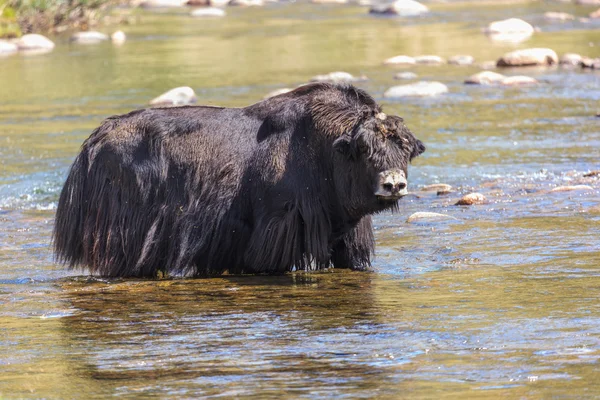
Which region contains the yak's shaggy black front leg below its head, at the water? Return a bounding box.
[331,215,375,270]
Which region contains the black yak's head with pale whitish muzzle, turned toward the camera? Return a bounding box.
[313,86,425,217]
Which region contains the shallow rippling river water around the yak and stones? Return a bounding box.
[0,2,600,399]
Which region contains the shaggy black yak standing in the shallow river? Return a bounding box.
[53,83,425,277]
